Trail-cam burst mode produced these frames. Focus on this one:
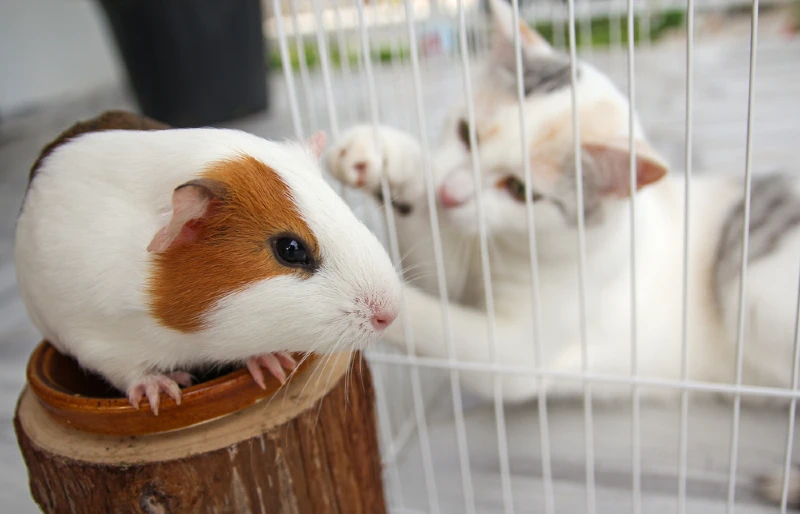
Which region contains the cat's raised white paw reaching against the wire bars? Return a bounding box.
[325,125,423,206]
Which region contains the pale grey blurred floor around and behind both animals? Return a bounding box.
[0,10,800,514]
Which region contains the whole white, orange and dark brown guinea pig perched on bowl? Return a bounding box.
[15,112,400,414]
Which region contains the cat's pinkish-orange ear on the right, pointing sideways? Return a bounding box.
[581,138,668,197]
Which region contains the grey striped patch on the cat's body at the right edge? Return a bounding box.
[714,174,800,304]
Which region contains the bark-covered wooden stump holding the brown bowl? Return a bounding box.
[14,353,386,514]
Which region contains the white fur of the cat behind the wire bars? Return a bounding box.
[327,2,800,401]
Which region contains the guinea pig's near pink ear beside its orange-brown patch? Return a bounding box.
[147,179,225,253]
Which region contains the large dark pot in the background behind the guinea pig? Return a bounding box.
[100,0,267,127]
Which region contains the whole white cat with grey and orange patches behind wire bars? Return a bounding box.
[327,1,800,401]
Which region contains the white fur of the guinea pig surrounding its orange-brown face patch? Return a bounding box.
[15,129,399,390]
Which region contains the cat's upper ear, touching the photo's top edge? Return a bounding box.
[489,0,553,66]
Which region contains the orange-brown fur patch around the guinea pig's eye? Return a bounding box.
[149,156,319,332]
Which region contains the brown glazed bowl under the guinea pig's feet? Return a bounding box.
[27,341,313,436]
